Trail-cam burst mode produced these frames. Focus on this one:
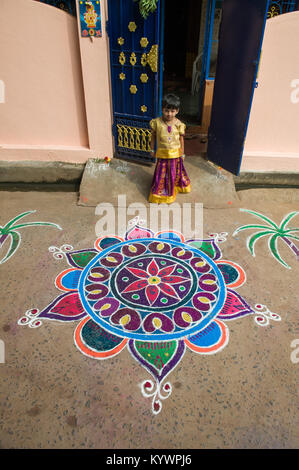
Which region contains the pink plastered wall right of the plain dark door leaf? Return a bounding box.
[241,11,299,172]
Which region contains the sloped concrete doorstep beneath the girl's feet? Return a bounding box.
[78,157,240,208]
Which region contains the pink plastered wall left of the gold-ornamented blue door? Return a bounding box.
[0,0,113,163]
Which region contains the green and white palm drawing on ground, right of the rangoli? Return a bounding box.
[233,209,299,269]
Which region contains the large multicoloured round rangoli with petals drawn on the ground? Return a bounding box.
[18,223,281,414]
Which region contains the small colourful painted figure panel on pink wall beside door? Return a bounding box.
[79,0,102,37]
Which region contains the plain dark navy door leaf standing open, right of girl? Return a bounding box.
[207,0,269,175]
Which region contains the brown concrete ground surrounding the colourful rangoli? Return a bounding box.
[0,162,299,449]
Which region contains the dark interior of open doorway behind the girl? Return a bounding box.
[163,0,202,125]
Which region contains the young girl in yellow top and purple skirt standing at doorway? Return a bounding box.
[148,94,191,204]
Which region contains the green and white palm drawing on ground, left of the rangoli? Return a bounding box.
[0,211,62,264]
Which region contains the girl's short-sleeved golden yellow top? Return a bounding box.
[150,117,186,158]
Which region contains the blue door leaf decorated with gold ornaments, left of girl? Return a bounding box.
[107,0,163,163]
